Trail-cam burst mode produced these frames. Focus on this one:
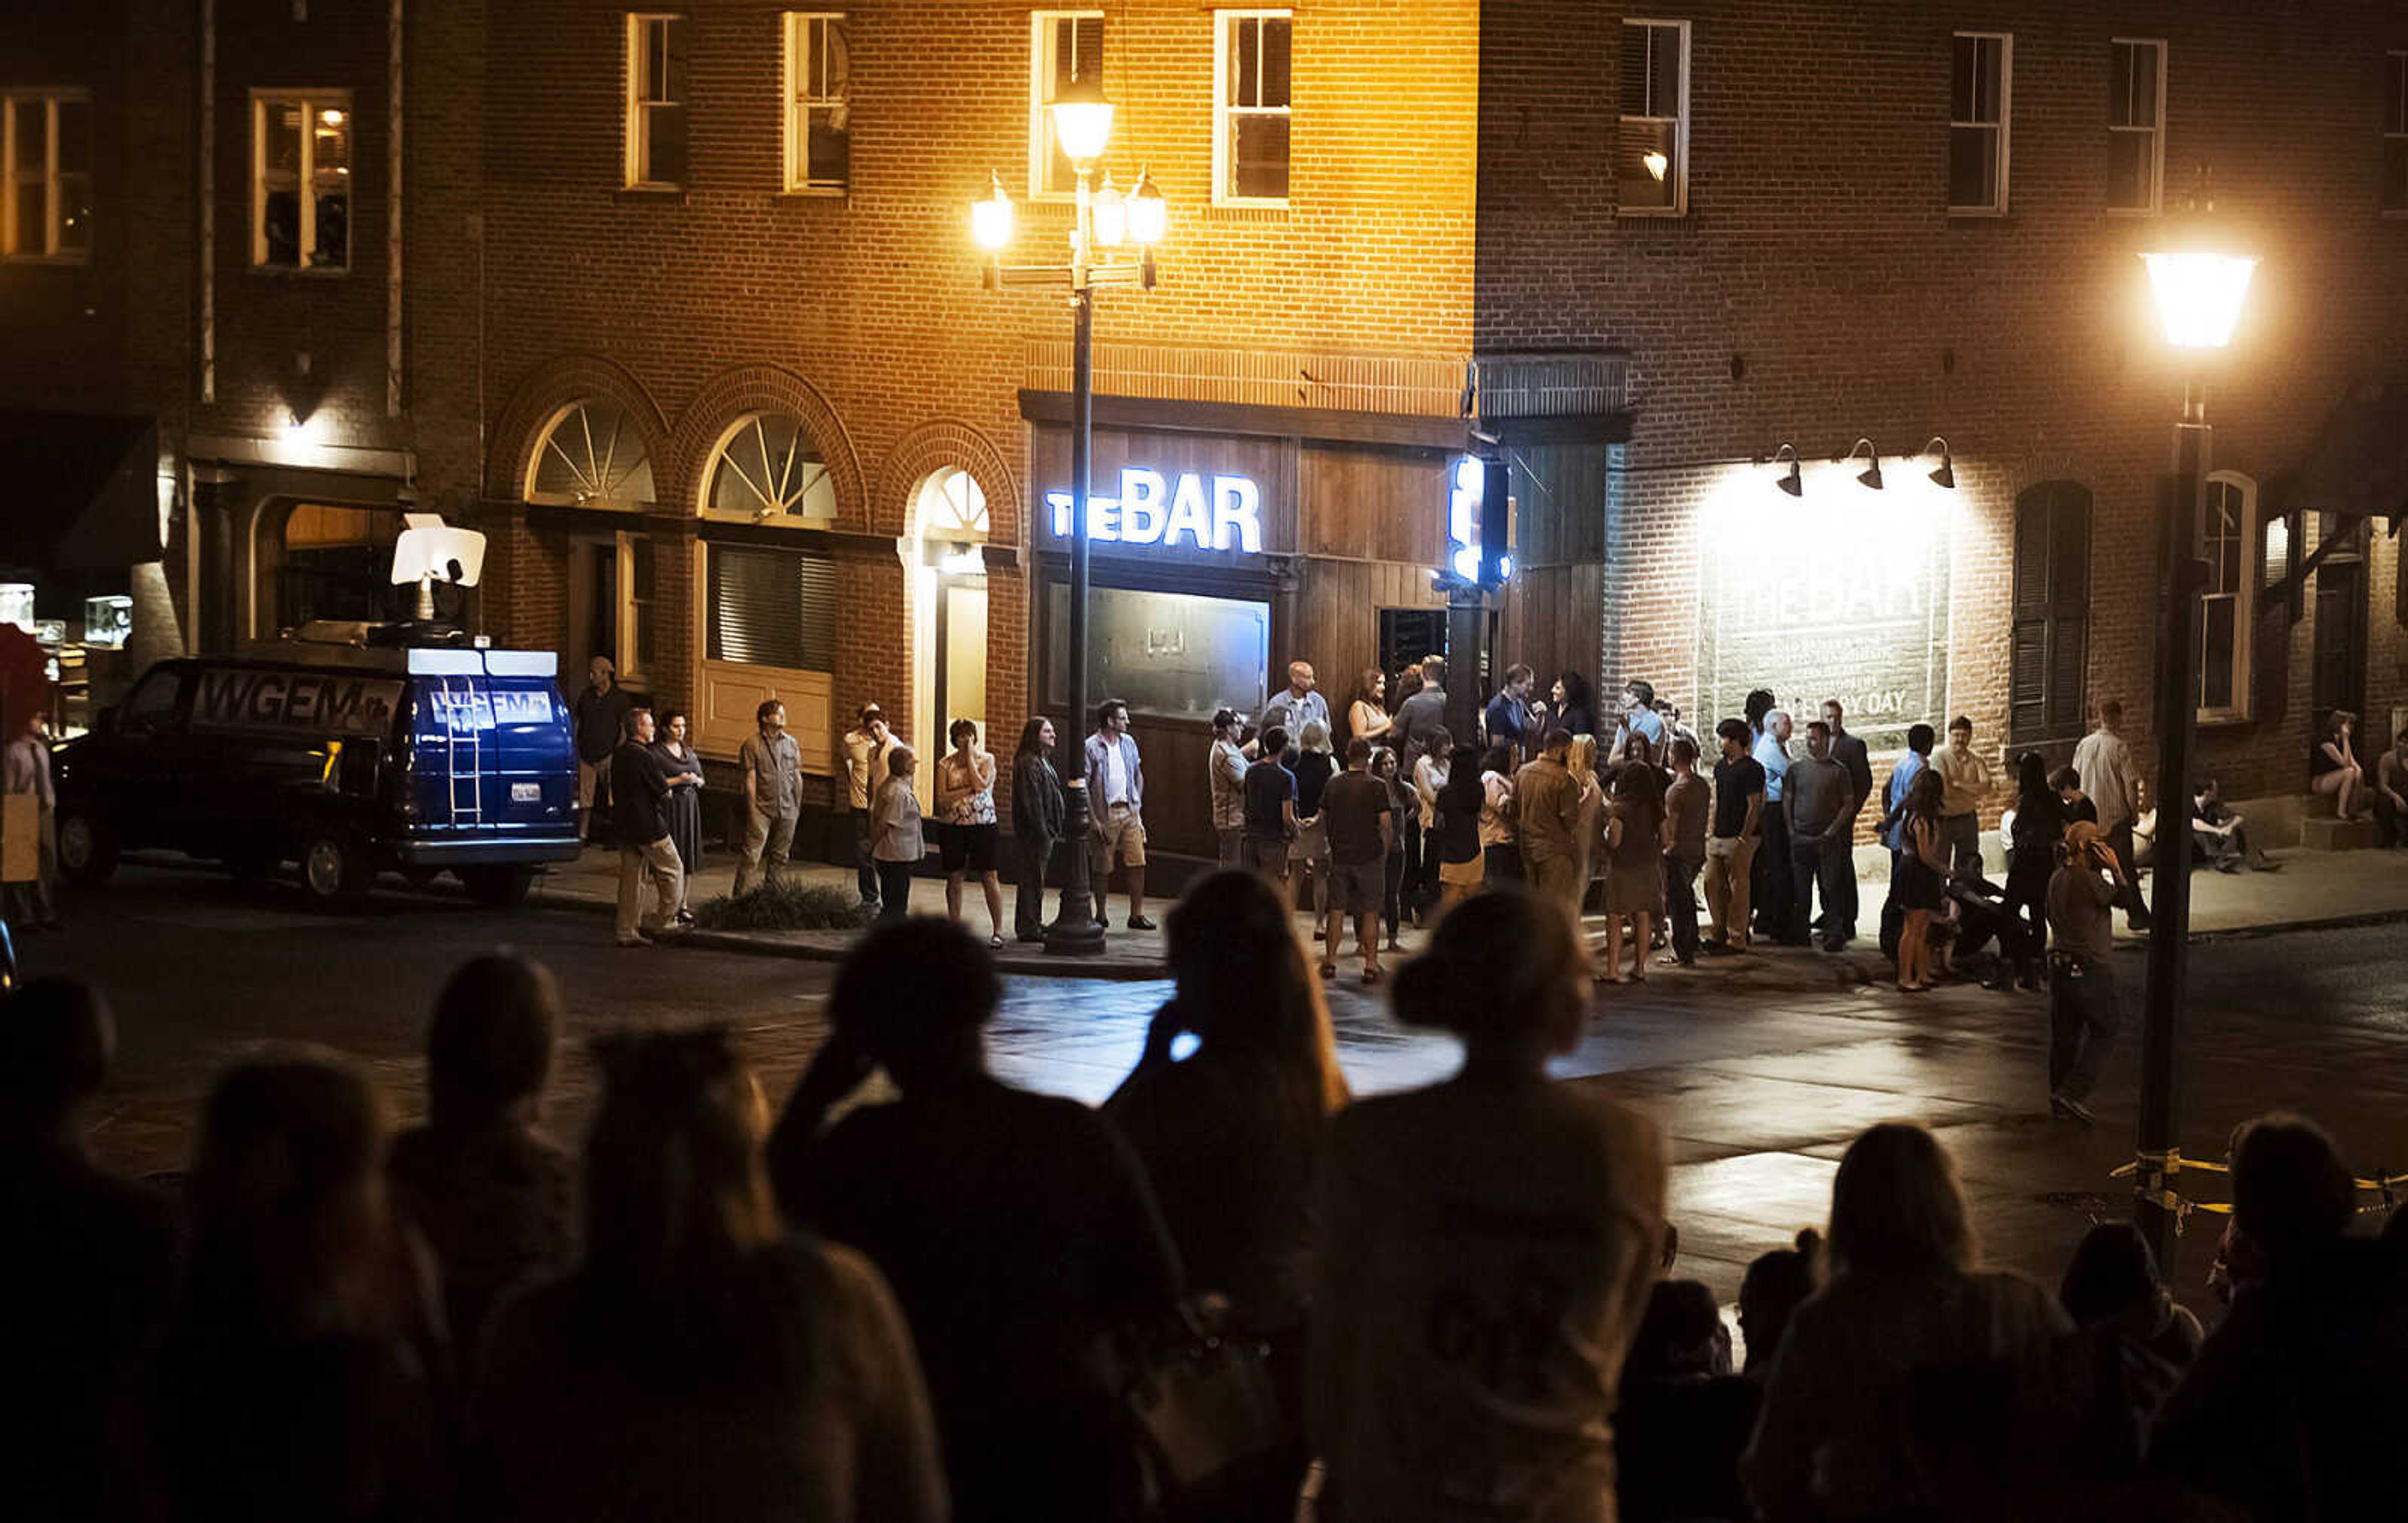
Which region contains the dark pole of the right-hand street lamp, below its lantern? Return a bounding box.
[2133,382,2213,1280]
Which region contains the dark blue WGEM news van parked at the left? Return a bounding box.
[55,635,578,905]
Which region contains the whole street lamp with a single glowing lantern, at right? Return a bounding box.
[2136,190,2256,1278]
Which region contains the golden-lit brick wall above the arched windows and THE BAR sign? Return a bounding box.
[469,0,1476,769]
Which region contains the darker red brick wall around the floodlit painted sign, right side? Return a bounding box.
[1476,0,2408,813]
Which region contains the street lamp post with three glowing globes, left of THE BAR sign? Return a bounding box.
[971,80,1166,957]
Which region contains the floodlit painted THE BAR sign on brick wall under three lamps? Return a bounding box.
[1698,491,1950,756]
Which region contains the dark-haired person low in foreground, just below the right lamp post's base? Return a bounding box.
[2056,1222,2201,1480]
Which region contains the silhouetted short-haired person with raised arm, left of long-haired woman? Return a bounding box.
[771,919,1180,1520]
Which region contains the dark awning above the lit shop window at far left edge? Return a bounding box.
[0,409,161,570]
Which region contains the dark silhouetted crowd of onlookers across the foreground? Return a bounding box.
[0,880,2408,1523]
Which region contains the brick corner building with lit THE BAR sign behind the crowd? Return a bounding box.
[0,0,2408,851]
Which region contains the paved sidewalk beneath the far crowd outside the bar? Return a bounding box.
[534,847,2408,979]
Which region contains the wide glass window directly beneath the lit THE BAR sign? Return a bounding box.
[1045,582,1272,724]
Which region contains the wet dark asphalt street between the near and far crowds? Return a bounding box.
[33,864,2408,1294]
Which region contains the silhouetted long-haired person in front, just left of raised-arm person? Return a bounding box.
[465,1028,946,1523]
